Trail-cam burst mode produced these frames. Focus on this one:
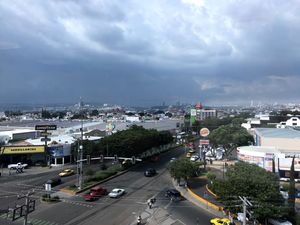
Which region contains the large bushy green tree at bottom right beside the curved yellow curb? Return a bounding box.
[212,162,286,221]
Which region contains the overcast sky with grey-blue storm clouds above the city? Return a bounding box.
[0,0,300,106]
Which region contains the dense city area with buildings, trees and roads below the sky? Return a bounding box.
[0,101,300,225]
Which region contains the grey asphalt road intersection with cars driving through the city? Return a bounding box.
[0,149,213,225]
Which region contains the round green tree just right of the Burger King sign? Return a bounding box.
[208,124,254,157]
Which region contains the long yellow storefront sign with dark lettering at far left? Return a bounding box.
[0,145,45,155]
